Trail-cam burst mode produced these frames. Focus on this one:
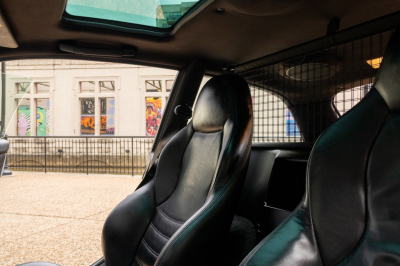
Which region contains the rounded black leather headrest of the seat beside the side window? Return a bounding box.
[193,74,251,133]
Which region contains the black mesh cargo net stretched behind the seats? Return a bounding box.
[238,31,392,142]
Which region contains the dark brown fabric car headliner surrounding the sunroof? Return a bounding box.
[0,0,400,74]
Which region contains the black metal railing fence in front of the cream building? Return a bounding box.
[7,136,154,176]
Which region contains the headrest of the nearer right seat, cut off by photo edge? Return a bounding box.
[374,29,400,112]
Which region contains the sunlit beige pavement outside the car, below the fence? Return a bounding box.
[0,171,141,266]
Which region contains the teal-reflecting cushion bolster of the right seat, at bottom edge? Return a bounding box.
[240,203,322,266]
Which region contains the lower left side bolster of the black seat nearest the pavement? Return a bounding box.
[101,180,156,266]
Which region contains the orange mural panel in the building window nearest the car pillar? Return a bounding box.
[146,97,162,136]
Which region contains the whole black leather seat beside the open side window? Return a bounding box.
[102,74,253,266]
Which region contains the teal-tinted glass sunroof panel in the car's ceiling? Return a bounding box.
[65,0,202,28]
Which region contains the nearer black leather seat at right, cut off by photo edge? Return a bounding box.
[241,30,400,266]
